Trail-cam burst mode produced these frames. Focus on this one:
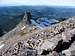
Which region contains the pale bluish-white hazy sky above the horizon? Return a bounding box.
[0,0,75,6]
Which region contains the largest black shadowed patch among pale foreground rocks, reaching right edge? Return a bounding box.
[54,35,75,53]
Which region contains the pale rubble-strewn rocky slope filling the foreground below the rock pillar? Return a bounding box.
[0,17,75,56]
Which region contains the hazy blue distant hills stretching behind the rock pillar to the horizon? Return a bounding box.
[0,6,75,32]
